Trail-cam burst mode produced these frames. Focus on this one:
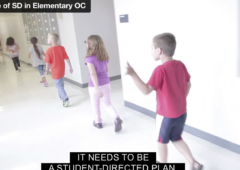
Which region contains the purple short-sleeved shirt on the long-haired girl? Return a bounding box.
[85,55,110,87]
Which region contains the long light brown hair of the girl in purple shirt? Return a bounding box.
[86,35,109,61]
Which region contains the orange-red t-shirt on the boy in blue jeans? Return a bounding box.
[44,45,69,79]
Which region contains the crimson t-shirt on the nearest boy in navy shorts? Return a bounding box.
[148,60,190,118]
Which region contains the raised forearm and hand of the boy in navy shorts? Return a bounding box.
[126,63,154,95]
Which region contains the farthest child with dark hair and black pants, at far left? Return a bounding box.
[6,37,21,72]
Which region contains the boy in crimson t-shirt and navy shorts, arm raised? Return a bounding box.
[126,33,203,170]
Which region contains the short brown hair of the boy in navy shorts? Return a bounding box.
[153,33,177,57]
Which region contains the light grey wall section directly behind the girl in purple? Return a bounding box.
[73,0,120,83]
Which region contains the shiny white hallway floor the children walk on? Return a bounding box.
[0,58,240,170]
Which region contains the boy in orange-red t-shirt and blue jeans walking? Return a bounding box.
[45,33,73,107]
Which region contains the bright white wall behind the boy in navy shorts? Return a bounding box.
[114,0,240,144]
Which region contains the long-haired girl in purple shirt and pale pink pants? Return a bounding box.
[85,35,122,132]
